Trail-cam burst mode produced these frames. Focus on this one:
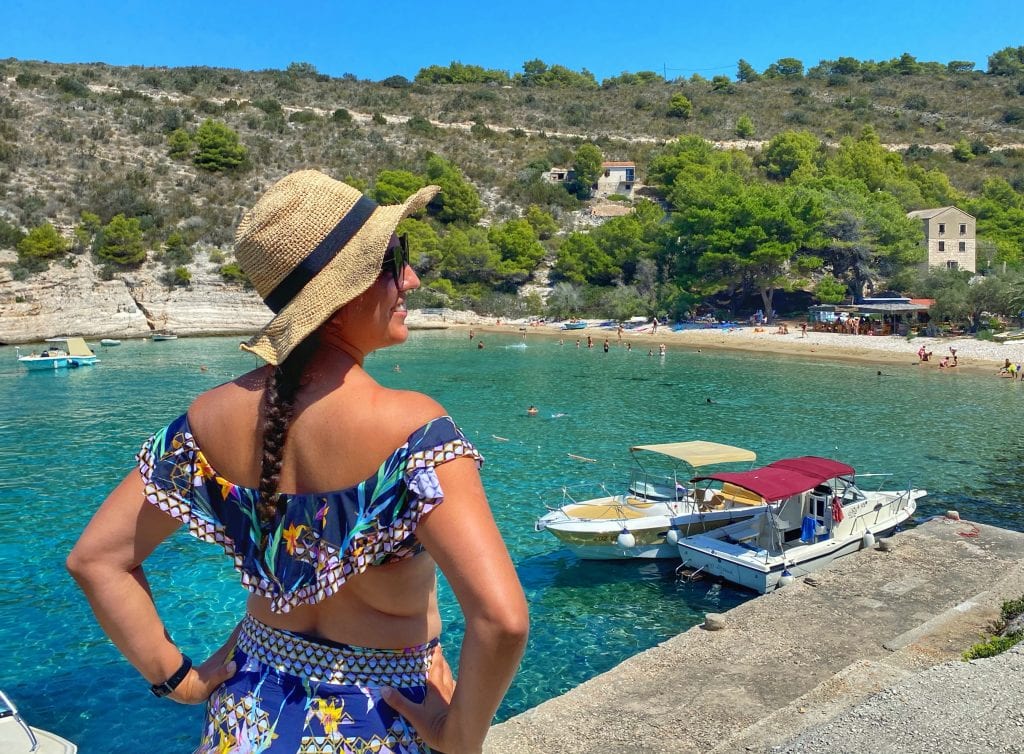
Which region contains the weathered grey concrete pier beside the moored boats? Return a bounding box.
[485,518,1024,754]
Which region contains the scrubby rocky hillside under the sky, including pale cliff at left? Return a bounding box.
[0,59,1024,342]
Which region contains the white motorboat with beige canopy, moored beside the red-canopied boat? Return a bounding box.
[534,441,764,559]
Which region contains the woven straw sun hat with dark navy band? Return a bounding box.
[234,170,440,364]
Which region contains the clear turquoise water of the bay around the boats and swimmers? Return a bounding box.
[0,331,1024,754]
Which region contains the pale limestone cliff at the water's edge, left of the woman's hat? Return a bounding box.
[0,251,270,343]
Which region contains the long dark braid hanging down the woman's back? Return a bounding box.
[256,333,319,532]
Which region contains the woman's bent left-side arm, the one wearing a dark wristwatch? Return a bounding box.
[67,469,233,703]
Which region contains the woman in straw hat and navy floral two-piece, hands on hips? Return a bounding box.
[68,170,527,754]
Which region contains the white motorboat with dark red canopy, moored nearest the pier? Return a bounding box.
[678,456,928,594]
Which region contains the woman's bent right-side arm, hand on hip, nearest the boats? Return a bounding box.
[385,457,529,754]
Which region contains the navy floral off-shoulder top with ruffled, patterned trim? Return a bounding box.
[136,414,483,613]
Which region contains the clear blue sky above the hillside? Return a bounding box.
[0,0,1024,81]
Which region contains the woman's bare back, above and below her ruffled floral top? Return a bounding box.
[188,362,443,647]
